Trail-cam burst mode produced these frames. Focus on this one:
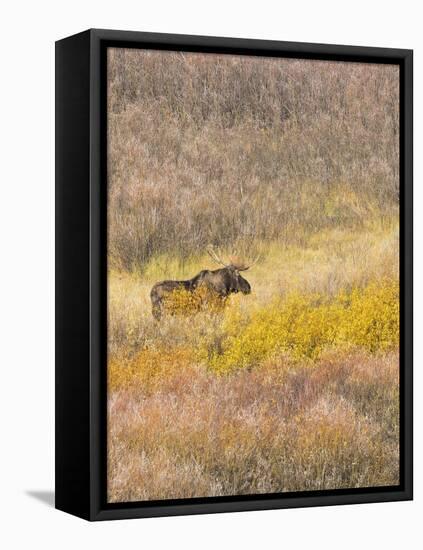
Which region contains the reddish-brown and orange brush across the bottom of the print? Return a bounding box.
[108,352,399,502]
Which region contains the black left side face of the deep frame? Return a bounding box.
[55,32,90,519]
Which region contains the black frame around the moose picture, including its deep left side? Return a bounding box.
[56,29,413,520]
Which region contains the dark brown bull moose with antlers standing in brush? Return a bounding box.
[150,246,258,320]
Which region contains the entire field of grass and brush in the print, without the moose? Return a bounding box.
[107,48,400,502]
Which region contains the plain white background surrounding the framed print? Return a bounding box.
[0,0,423,550]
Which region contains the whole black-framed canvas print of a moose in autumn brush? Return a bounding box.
[56,30,412,520]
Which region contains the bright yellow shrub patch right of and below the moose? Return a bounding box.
[208,280,399,372]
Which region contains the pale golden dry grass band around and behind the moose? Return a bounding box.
[108,222,399,358]
